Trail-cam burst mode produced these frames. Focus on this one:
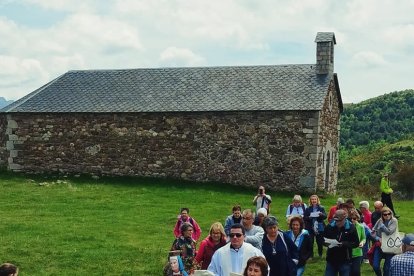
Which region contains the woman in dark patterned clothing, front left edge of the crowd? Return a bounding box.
[171,222,196,272]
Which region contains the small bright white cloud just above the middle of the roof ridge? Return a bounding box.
[159,47,204,66]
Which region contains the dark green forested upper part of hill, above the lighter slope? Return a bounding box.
[341,90,414,149]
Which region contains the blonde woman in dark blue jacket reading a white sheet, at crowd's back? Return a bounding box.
[303,195,326,258]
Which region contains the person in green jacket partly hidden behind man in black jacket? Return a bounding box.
[350,210,366,276]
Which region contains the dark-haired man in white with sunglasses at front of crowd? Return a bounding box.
[207,223,264,276]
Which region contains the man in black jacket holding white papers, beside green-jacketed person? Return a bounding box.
[324,209,359,276]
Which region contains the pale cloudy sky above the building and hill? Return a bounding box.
[0,0,414,103]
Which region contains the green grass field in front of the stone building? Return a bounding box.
[0,173,414,276]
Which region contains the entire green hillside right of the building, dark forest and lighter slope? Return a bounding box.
[338,90,414,199]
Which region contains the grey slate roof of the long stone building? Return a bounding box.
[0,64,342,113]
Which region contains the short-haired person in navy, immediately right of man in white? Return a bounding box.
[262,216,299,276]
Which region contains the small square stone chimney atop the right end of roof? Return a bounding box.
[315,32,336,75]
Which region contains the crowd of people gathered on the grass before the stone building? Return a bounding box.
[164,174,414,276]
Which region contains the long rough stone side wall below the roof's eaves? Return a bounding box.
[0,112,319,191]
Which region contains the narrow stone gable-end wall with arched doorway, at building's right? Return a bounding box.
[316,81,340,193]
